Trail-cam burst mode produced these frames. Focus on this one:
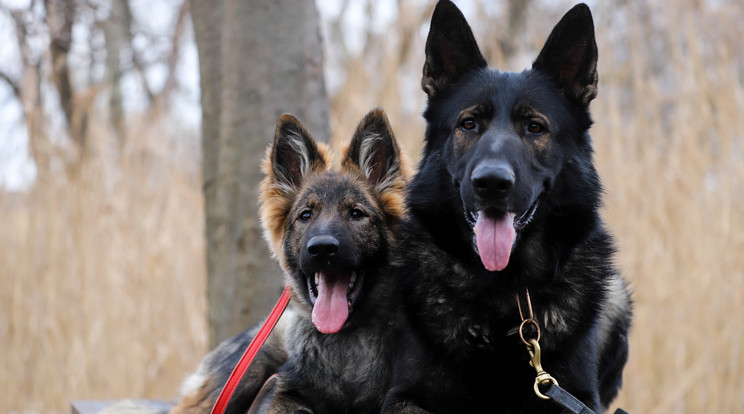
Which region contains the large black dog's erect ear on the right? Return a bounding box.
[532,3,597,106]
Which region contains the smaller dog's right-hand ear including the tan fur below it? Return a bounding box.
[342,109,409,221]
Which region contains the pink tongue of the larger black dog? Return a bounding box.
[474,211,517,272]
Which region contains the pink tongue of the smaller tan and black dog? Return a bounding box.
[313,272,351,334]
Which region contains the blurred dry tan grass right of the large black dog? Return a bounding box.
[594,2,744,413]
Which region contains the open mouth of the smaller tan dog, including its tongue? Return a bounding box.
[306,269,364,334]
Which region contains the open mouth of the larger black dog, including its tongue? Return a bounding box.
[465,197,540,272]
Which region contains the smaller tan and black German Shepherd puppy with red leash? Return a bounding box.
[170,109,408,413]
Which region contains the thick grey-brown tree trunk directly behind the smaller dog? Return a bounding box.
[191,0,329,346]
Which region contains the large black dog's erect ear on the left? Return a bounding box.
[421,0,486,98]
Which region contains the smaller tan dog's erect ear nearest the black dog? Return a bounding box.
[342,108,405,192]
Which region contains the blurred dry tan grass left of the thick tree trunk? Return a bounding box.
[0,115,207,413]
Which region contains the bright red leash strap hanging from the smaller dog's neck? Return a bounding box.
[212,286,289,414]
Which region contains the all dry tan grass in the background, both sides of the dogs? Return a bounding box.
[0,1,744,413]
